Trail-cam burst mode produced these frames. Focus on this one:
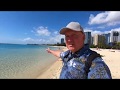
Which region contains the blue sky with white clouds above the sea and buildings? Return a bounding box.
[0,11,120,44]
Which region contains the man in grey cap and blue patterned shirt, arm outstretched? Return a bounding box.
[47,22,112,79]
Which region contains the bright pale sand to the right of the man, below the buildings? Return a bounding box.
[93,49,120,79]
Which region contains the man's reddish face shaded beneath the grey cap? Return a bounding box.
[65,30,85,53]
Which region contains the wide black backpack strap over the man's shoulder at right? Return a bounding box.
[84,51,101,75]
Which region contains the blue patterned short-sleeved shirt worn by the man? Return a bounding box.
[60,46,112,79]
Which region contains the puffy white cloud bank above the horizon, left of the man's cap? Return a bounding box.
[22,26,64,44]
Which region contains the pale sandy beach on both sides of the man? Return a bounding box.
[37,47,120,79]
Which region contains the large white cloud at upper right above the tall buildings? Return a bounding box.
[88,11,120,26]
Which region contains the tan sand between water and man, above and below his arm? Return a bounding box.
[37,46,67,79]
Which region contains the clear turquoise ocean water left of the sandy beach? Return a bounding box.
[0,44,58,79]
